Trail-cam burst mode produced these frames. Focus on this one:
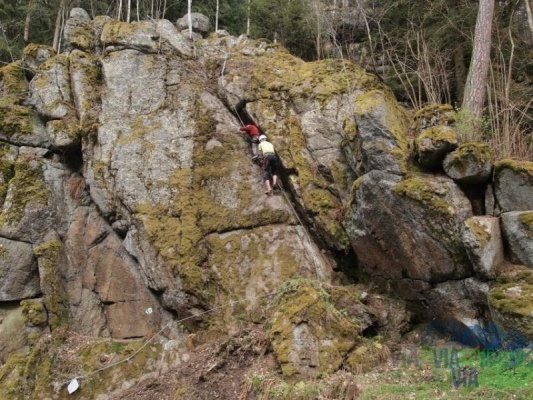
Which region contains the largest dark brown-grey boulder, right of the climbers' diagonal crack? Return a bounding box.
[344,171,472,297]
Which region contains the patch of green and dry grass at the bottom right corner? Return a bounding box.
[357,348,533,400]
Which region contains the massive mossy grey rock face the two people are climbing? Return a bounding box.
[0,9,533,398]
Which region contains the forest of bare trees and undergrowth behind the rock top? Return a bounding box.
[0,0,533,161]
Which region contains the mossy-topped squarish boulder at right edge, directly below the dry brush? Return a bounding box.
[494,159,533,212]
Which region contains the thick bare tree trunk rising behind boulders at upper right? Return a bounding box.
[463,0,495,118]
